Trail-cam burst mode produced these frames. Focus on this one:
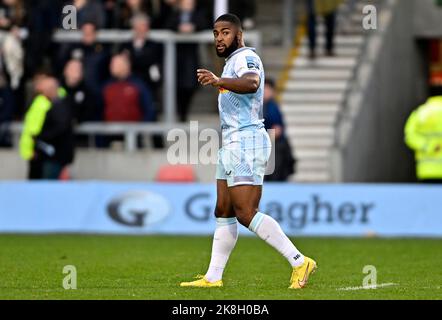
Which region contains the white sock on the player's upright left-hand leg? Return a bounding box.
[206,218,238,282]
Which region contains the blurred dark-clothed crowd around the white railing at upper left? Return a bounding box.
[0,0,255,146]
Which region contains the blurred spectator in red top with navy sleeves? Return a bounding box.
[103,54,155,122]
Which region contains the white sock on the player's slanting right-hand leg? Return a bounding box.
[249,212,304,267]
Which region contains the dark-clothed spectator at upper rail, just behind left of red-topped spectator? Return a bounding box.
[58,23,110,106]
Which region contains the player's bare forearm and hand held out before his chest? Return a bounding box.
[197,69,261,94]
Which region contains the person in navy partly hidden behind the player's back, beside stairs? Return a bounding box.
[264,78,296,181]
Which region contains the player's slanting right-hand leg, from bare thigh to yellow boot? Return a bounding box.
[229,185,316,289]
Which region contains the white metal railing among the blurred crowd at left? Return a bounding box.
[0,29,262,151]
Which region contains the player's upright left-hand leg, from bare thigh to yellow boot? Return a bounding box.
[181,180,238,287]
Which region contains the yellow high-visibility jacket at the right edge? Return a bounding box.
[405,96,442,180]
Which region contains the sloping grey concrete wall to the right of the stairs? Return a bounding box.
[332,0,427,182]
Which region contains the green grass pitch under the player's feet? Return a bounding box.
[0,235,442,300]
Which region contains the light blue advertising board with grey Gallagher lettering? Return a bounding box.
[0,182,442,237]
